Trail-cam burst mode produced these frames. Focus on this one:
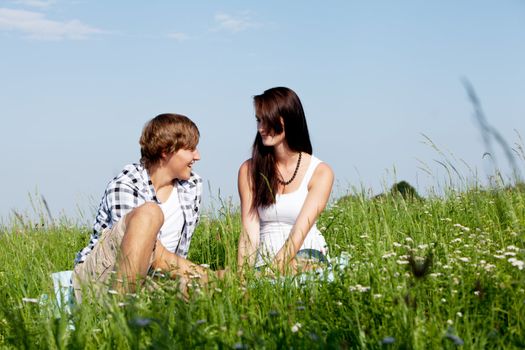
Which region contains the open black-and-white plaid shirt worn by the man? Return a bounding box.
[75,164,202,265]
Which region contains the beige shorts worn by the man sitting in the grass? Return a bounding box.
[72,217,155,303]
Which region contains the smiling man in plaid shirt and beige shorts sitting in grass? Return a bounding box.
[72,114,208,302]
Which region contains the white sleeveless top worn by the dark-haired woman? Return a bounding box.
[255,155,327,267]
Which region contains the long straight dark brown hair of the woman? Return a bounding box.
[250,87,312,210]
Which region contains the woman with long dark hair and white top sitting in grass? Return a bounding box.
[238,87,334,273]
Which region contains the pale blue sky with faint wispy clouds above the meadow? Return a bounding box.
[0,0,525,222]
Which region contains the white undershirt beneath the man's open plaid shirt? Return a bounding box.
[158,186,184,253]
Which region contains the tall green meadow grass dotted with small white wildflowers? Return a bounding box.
[0,182,525,349]
